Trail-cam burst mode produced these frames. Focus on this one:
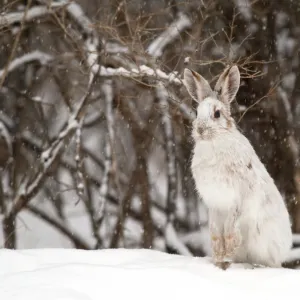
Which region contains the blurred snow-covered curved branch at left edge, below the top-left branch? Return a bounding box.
[0,50,53,77]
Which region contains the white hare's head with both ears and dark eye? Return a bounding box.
[183,66,240,139]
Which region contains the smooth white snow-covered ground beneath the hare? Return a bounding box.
[0,249,300,300]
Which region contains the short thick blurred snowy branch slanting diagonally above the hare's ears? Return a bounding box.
[147,13,192,57]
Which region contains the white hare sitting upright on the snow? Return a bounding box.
[184,66,292,269]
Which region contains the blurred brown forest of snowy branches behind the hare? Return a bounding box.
[0,0,300,266]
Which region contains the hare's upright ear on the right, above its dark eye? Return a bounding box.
[215,66,240,103]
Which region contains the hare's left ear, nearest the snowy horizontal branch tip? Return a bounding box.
[183,69,212,102]
